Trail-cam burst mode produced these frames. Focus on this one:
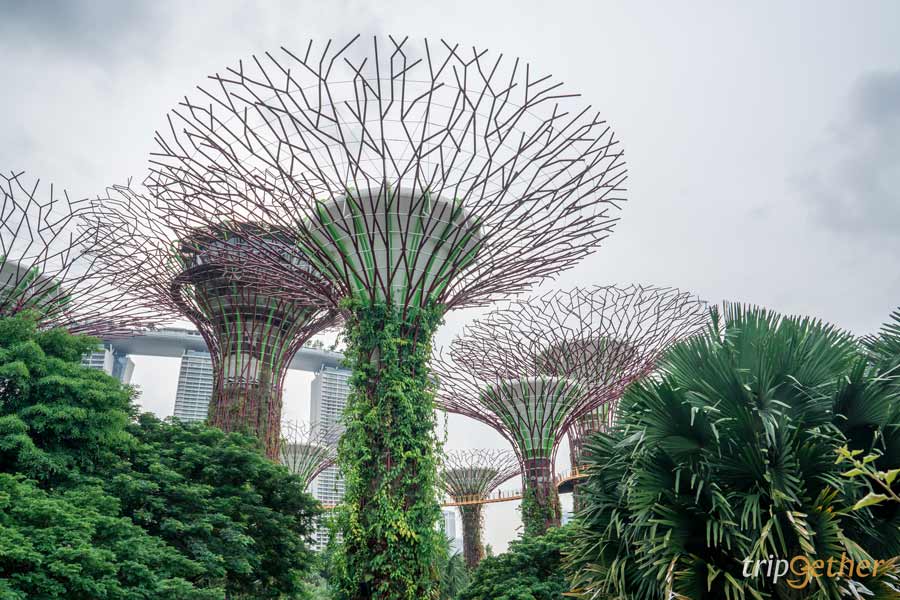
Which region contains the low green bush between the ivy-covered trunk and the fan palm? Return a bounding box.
[460,526,573,600]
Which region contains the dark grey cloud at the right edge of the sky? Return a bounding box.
[795,71,900,237]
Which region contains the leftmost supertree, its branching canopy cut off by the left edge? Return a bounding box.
[0,172,164,338]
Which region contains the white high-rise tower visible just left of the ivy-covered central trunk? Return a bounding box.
[310,367,351,547]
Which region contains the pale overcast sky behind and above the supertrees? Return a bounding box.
[0,0,900,550]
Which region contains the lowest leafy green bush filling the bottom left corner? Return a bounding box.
[0,473,222,600]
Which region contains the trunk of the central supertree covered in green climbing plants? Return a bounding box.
[336,301,443,600]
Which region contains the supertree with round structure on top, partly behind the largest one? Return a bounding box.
[82,186,337,460]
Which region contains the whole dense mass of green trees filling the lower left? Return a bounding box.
[0,315,318,600]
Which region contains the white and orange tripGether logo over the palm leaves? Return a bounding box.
[744,553,888,590]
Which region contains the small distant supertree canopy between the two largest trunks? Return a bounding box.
[279,421,341,487]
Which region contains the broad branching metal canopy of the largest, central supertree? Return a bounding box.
[147,38,626,318]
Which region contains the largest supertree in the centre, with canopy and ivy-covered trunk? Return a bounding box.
[148,38,625,599]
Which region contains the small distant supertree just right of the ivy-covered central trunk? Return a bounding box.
[440,449,520,568]
